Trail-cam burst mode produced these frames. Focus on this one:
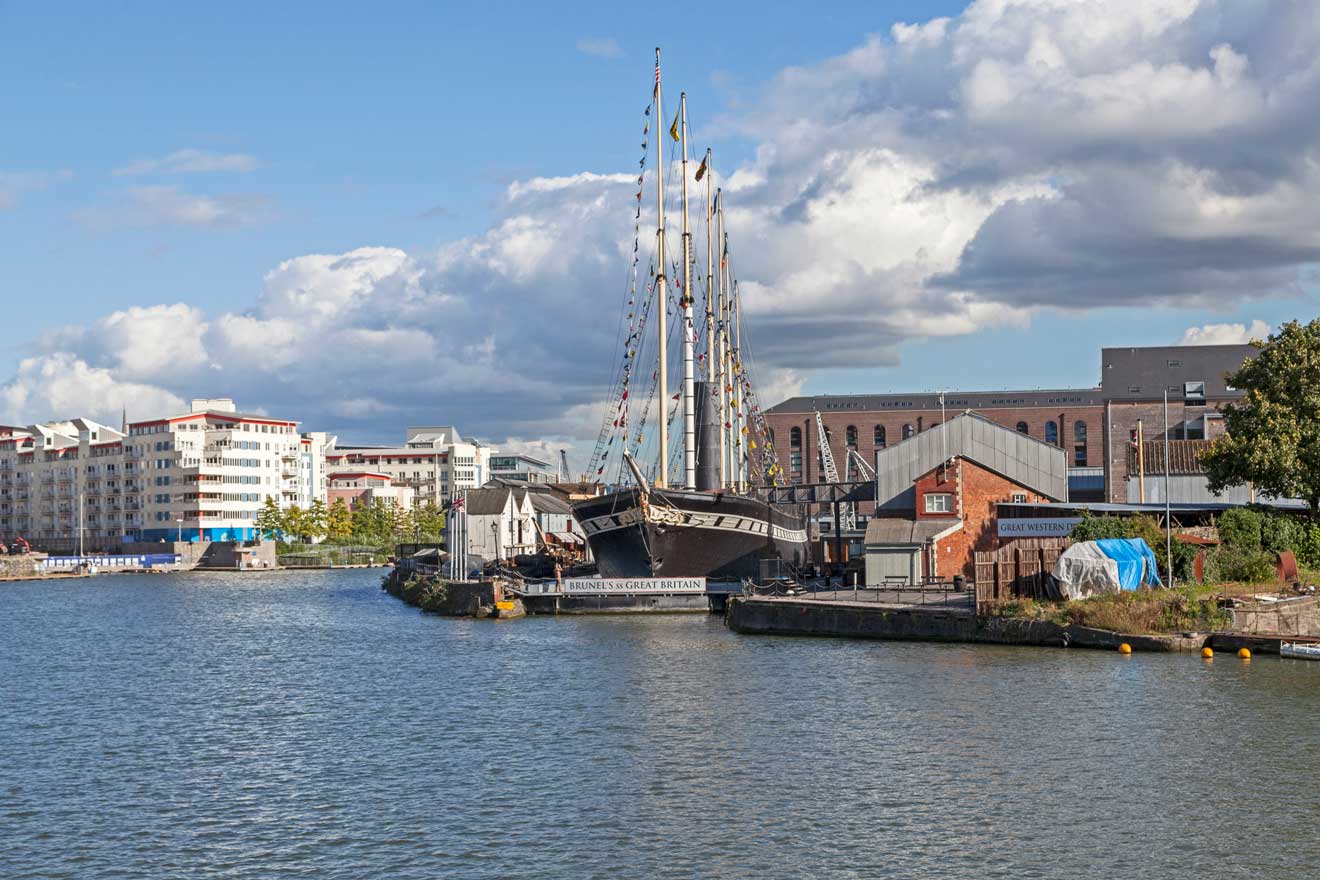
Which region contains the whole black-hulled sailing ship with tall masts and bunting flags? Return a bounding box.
[573,49,808,579]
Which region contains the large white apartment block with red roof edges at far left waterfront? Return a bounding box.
[0,398,334,549]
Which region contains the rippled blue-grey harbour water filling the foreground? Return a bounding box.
[0,570,1320,880]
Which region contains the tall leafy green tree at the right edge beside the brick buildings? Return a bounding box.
[1201,318,1320,522]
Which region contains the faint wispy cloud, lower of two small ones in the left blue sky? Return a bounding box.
[74,185,272,228]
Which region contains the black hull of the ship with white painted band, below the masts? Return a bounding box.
[573,489,808,581]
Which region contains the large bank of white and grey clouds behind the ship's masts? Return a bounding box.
[2,0,1320,461]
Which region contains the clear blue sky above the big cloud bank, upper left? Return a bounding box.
[0,3,956,337]
